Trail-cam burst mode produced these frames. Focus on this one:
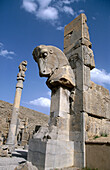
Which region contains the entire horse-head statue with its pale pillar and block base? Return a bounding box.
[28,45,75,170]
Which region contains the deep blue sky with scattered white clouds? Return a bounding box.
[0,0,110,114]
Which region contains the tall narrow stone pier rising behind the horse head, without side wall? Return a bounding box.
[64,14,95,168]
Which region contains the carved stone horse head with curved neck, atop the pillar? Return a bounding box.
[33,45,75,89]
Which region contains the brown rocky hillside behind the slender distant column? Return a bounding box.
[0,100,49,139]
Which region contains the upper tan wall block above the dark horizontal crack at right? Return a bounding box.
[83,82,110,119]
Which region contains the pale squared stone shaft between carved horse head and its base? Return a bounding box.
[49,87,70,141]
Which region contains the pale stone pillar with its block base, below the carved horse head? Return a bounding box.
[28,86,74,170]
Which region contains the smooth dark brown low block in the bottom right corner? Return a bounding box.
[86,142,110,170]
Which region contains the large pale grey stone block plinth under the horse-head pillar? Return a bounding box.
[28,139,74,170]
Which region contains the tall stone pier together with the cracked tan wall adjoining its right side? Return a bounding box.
[64,14,110,166]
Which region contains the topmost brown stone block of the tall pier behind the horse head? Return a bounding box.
[64,14,91,53]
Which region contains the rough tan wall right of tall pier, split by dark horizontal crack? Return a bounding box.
[83,82,110,140]
